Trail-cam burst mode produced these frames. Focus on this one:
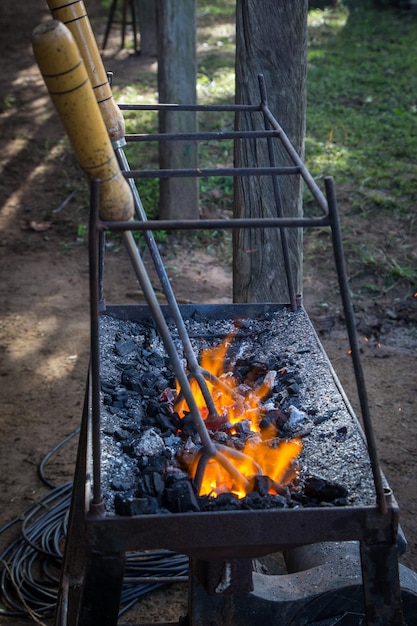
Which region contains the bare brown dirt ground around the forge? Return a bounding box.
[0,0,417,625]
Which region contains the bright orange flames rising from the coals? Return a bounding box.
[175,335,302,498]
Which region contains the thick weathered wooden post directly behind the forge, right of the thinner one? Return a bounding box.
[233,0,308,302]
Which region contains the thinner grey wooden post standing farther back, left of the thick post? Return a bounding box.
[157,0,199,219]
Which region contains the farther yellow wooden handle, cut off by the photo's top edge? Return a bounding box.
[47,0,125,142]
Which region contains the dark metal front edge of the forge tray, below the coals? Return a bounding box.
[83,505,398,560]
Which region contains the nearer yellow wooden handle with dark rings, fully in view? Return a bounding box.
[32,20,133,221]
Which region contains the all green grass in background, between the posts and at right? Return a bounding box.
[107,0,417,297]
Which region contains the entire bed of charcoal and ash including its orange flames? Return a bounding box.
[100,305,374,515]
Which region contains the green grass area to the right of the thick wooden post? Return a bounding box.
[305,2,417,293]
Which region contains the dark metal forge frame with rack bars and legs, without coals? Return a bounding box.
[56,84,417,626]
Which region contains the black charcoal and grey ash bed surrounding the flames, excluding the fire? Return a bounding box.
[100,307,375,515]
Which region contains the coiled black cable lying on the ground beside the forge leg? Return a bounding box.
[0,429,188,622]
